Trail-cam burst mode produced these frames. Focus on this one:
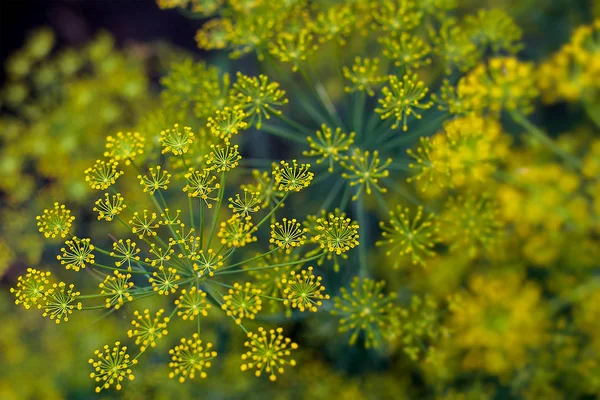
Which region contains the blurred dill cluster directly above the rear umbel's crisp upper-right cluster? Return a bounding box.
[378,32,431,71]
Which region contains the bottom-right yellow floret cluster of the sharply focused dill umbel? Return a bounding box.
[241,327,298,382]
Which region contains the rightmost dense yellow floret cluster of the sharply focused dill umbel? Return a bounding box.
[314,213,358,256]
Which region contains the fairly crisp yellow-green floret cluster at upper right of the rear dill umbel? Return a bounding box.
[375,74,433,131]
